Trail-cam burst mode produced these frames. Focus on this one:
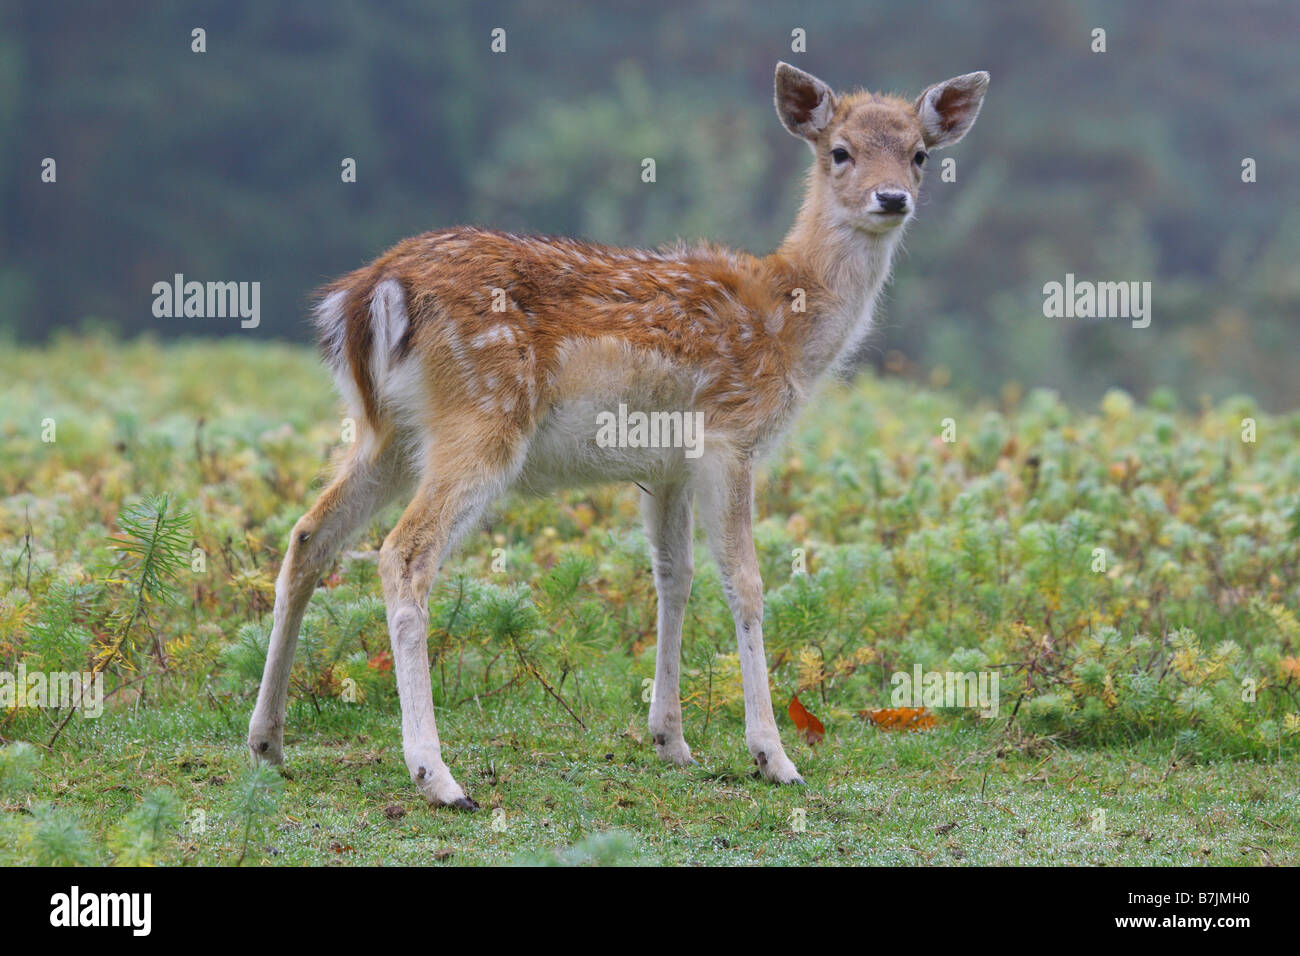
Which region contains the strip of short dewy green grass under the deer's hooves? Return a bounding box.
[20,701,1300,866]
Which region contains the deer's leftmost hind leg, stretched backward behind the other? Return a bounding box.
[248,445,407,763]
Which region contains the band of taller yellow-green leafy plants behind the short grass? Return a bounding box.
[0,342,1300,760]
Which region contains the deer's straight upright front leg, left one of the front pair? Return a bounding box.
[641,484,696,766]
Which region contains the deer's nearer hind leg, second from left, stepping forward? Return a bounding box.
[380,425,519,810]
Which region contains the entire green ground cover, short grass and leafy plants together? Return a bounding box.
[0,336,1300,865]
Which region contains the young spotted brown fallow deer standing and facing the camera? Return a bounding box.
[248,62,989,810]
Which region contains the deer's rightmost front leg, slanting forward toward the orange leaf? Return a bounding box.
[705,459,803,784]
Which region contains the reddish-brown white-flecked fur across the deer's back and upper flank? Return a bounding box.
[321,228,827,441]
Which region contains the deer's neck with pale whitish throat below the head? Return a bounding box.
[772,185,902,382]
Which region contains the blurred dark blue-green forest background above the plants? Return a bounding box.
[0,0,1300,410]
